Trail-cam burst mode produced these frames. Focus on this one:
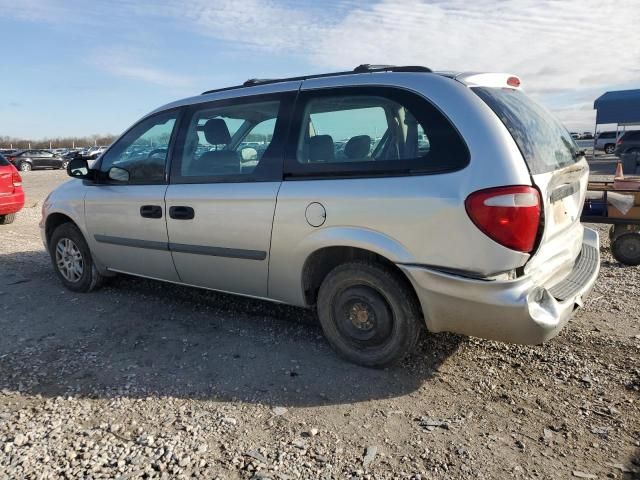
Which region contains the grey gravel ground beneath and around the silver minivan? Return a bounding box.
[0,171,640,479]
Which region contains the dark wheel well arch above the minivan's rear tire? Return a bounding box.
[302,247,420,316]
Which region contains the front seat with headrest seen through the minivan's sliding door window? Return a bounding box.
[194,118,241,176]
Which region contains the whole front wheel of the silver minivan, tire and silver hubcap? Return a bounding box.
[49,223,103,293]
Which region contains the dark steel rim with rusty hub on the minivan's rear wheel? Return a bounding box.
[333,286,394,347]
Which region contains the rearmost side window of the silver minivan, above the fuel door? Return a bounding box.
[287,87,469,176]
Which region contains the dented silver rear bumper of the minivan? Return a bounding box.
[400,228,600,345]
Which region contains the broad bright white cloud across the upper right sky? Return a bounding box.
[147,0,640,129]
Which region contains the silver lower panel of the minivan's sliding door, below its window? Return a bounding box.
[166,182,280,297]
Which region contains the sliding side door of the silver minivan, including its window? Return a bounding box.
[166,92,295,297]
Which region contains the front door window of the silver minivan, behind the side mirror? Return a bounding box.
[100,111,178,184]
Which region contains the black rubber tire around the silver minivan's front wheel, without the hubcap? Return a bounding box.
[49,223,104,293]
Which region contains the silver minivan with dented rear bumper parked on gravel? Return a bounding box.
[40,65,600,367]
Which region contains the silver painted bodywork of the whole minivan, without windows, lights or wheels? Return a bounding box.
[44,72,598,343]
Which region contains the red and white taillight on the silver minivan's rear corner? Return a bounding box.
[465,185,541,252]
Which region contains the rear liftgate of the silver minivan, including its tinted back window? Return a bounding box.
[473,87,589,278]
